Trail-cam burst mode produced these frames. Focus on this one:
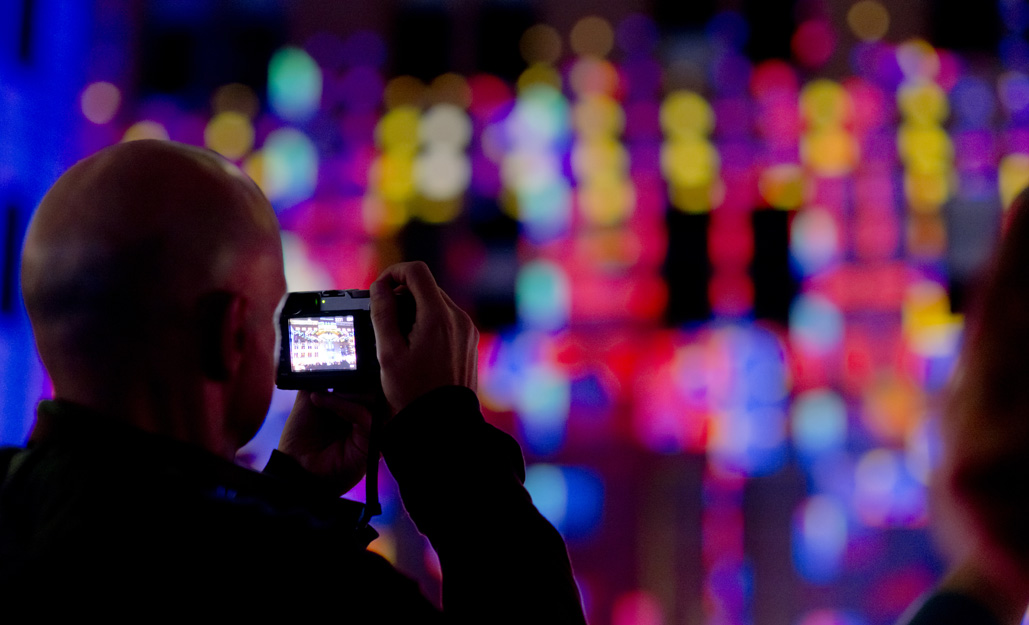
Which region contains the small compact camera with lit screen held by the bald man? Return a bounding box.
[275,288,380,392]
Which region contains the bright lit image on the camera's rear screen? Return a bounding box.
[289,315,357,373]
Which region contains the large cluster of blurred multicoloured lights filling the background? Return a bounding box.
[72,0,1029,625]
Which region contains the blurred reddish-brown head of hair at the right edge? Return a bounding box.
[939,185,1029,583]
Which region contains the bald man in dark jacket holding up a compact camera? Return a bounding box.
[0,141,584,623]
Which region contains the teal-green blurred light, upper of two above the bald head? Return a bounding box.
[268,47,322,121]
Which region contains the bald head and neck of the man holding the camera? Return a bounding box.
[22,141,285,457]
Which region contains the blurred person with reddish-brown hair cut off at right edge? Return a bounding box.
[900,189,1029,625]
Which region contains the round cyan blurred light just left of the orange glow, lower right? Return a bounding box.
[790,388,847,458]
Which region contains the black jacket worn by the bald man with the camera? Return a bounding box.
[0,387,583,623]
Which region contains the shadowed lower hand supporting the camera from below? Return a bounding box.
[279,390,372,495]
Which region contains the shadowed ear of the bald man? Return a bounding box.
[197,290,247,381]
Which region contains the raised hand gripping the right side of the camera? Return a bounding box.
[371,262,478,414]
